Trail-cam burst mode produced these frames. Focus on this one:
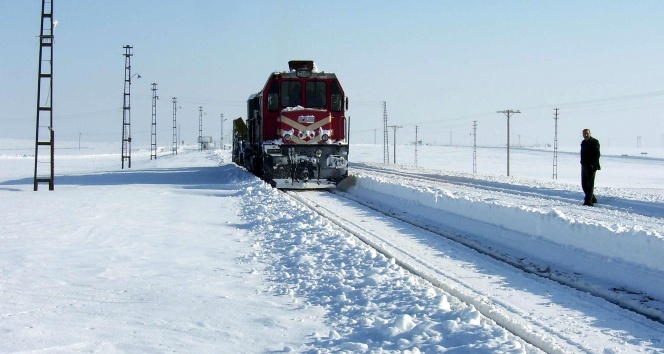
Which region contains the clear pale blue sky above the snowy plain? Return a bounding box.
[0,0,664,149]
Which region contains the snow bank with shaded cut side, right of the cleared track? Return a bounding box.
[348,173,664,298]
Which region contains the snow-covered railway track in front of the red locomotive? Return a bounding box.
[287,187,662,353]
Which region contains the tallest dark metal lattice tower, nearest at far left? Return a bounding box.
[34,0,55,191]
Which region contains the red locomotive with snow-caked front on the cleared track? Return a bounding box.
[232,60,350,189]
